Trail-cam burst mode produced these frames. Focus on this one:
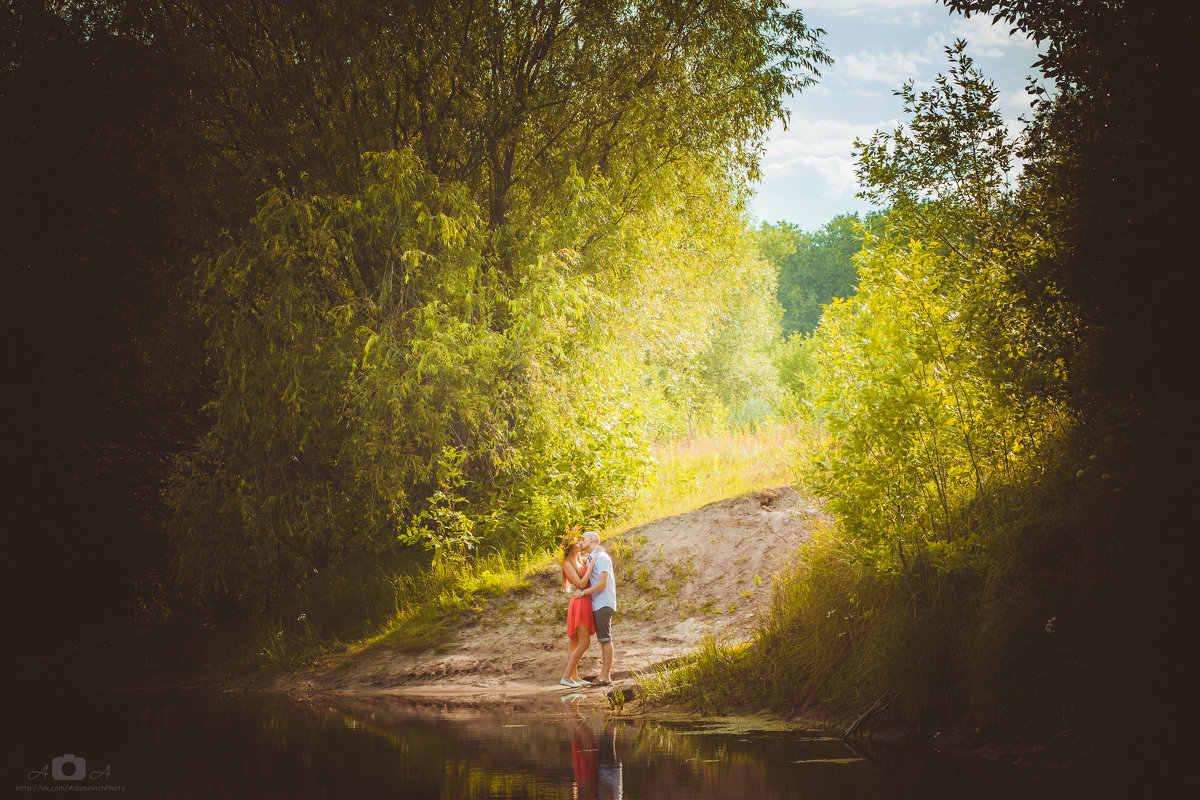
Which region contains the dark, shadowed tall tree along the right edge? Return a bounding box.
[947,0,1200,758]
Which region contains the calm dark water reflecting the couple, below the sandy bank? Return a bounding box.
[5,692,1123,800]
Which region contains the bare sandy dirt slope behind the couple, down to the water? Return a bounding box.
[280,487,826,702]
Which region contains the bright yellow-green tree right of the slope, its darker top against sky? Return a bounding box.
[805,42,1073,565]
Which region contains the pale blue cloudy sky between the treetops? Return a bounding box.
[750,0,1038,230]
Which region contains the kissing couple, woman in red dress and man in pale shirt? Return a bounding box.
[558,528,617,688]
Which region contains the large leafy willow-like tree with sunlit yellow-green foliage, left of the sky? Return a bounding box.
[163,1,828,608]
